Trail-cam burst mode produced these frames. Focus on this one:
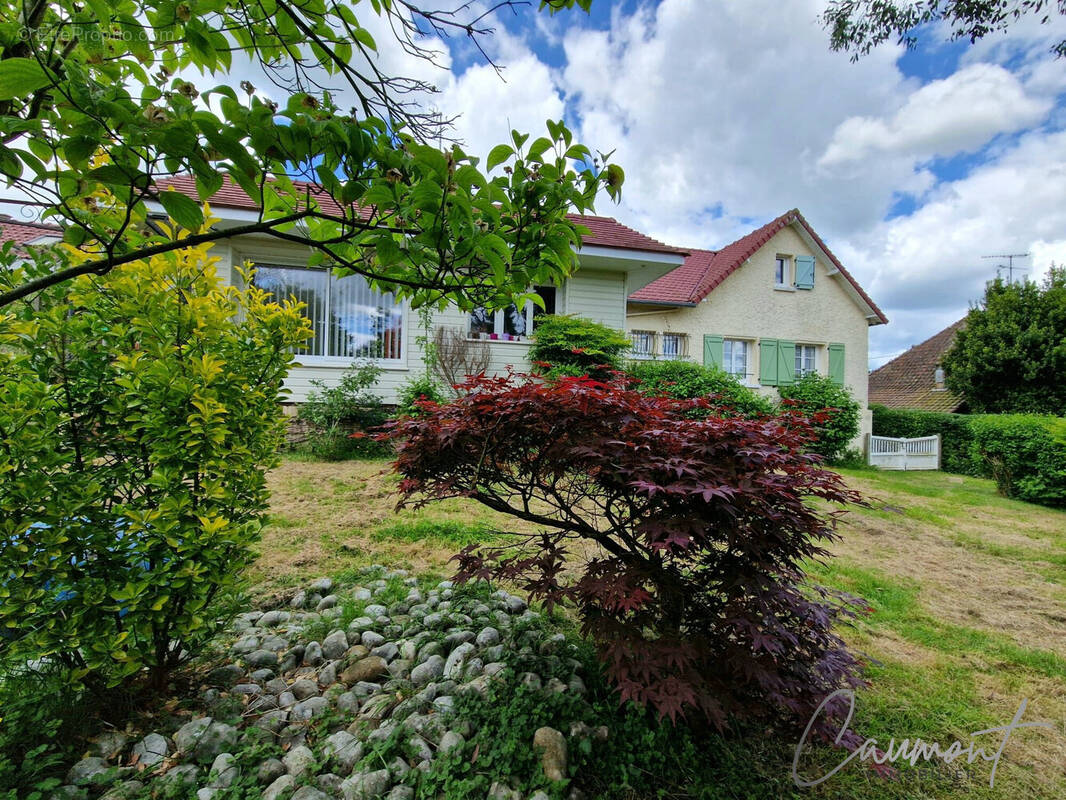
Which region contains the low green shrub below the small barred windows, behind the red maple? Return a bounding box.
[626,361,774,417]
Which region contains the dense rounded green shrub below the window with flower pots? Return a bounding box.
[529,315,630,381]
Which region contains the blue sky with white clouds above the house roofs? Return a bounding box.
[368,0,1066,367]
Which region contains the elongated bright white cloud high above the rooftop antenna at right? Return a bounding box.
[819,64,1053,167]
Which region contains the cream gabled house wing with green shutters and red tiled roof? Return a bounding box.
[626,209,888,442]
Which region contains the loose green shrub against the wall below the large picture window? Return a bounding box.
[298,362,388,461]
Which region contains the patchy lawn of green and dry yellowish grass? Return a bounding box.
[254,460,1066,800]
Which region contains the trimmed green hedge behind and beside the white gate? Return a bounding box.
[870,405,1066,507]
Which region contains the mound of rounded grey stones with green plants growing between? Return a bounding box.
[51,567,639,800]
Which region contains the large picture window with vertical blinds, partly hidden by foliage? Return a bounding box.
[253,265,403,361]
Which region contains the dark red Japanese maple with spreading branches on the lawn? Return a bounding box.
[391,375,861,735]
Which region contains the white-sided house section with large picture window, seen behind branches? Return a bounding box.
[149,176,685,403]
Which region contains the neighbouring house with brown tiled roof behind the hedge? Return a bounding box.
[870,317,966,413]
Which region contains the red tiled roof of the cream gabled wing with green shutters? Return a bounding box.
[629,208,888,323]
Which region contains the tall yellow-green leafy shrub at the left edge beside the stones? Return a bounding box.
[0,240,309,695]
